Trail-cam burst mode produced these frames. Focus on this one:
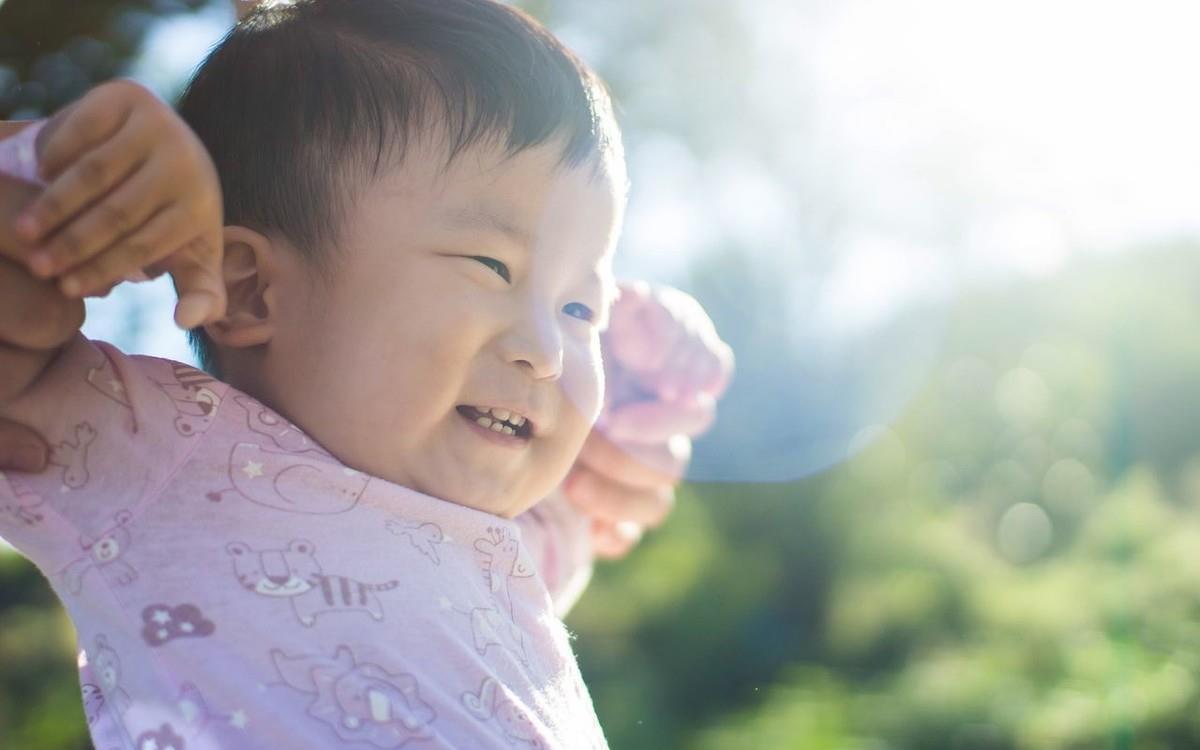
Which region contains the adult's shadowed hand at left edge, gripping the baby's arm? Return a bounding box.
[0,175,83,472]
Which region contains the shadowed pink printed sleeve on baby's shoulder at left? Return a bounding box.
[0,336,226,566]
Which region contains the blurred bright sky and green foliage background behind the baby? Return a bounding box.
[0,0,1200,750]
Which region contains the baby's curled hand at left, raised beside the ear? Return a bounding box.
[17,80,226,328]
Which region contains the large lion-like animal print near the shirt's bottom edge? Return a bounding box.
[271,646,437,749]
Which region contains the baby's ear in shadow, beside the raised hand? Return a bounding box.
[204,227,280,348]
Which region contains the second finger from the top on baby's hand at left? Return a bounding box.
[18,117,146,247]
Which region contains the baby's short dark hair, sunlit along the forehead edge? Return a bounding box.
[179,0,624,370]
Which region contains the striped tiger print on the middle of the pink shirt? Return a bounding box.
[226,539,400,626]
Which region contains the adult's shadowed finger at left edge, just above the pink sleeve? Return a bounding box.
[0,258,84,349]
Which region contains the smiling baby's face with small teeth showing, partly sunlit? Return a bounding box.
[268,139,620,517]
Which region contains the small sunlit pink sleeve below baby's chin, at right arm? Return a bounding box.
[516,490,594,617]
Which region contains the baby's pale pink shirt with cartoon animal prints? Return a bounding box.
[0,337,607,750]
